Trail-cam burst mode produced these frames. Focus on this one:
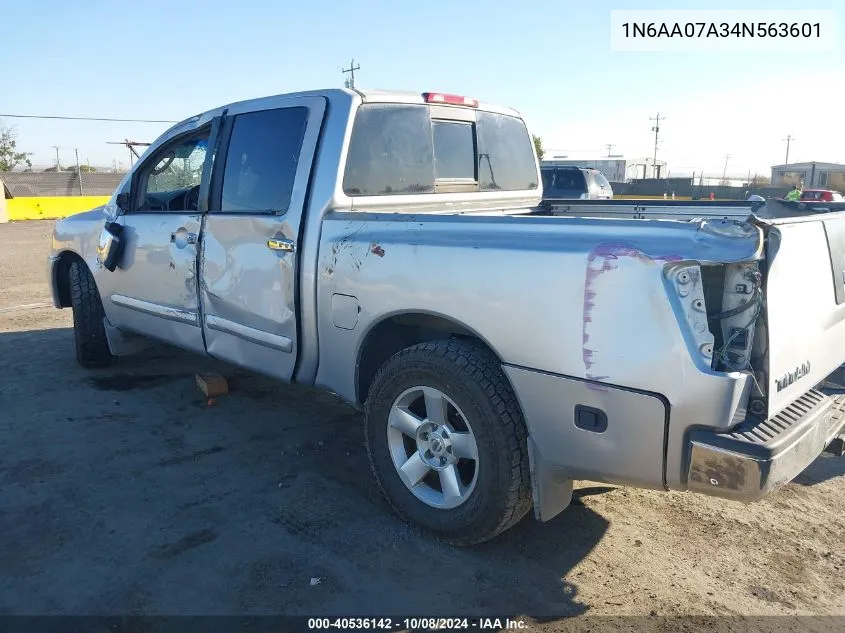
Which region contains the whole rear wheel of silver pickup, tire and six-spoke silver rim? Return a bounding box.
[366,340,531,545]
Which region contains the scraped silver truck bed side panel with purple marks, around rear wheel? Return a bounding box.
[317,212,760,489]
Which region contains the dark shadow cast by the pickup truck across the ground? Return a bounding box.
[0,328,613,620]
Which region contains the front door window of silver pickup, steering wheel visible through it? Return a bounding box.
[136,128,210,212]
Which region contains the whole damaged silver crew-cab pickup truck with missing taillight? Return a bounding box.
[48,90,845,545]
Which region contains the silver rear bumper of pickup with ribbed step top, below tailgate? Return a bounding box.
[687,390,845,503]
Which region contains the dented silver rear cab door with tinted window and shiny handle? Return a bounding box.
[200,97,325,380]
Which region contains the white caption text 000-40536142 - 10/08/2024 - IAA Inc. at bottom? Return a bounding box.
[308,618,528,631]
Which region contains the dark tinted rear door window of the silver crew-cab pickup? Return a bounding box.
[221,107,308,213]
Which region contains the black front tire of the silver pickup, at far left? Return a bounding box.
[70,262,114,369]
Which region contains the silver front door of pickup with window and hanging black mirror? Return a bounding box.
[98,122,216,352]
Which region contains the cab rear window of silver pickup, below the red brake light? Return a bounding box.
[343,104,537,196]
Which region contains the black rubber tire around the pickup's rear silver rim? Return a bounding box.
[365,340,531,546]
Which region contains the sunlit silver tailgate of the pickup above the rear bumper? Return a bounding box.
[764,213,845,417]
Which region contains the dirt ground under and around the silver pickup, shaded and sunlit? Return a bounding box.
[0,222,845,631]
